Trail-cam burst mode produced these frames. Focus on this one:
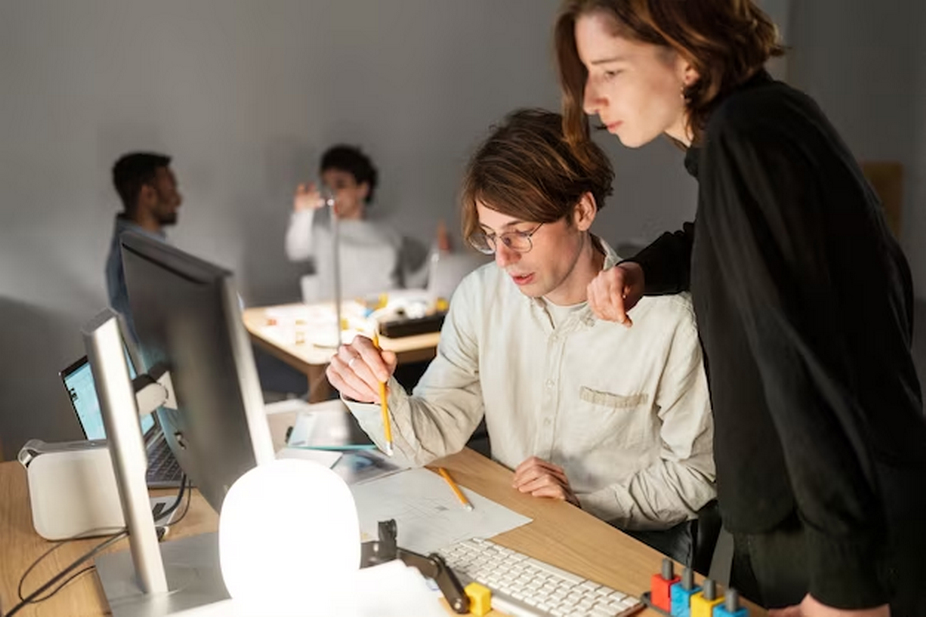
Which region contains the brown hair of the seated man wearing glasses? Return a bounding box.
[462,109,614,240]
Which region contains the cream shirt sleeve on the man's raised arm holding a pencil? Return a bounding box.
[344,280,485,466]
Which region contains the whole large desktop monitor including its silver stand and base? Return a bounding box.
[83,232,274,617]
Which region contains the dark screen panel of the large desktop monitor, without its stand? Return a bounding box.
[121,233,273,512]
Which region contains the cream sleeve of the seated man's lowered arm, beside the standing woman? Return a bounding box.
[579,300,716,529]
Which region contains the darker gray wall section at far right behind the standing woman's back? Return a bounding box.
[789,0,926,288]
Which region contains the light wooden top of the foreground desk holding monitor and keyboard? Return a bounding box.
[0,413,765,617]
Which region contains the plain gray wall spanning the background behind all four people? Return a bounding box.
[0,0,926,457]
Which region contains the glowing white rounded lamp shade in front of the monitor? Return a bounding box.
[219,459,360,615]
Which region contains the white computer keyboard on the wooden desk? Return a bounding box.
[438,538,643,617]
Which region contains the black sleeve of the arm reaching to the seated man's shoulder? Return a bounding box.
[626,223,694,296]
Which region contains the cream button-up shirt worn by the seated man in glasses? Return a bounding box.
[346,242,715,529]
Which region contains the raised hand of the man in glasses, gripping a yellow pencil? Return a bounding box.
[325,336,396,403]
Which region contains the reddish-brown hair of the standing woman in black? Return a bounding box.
[554,0,784,143]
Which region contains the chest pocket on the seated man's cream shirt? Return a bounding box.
[579,386,659,446]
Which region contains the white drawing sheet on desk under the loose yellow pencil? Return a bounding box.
[351,469,531,555]
